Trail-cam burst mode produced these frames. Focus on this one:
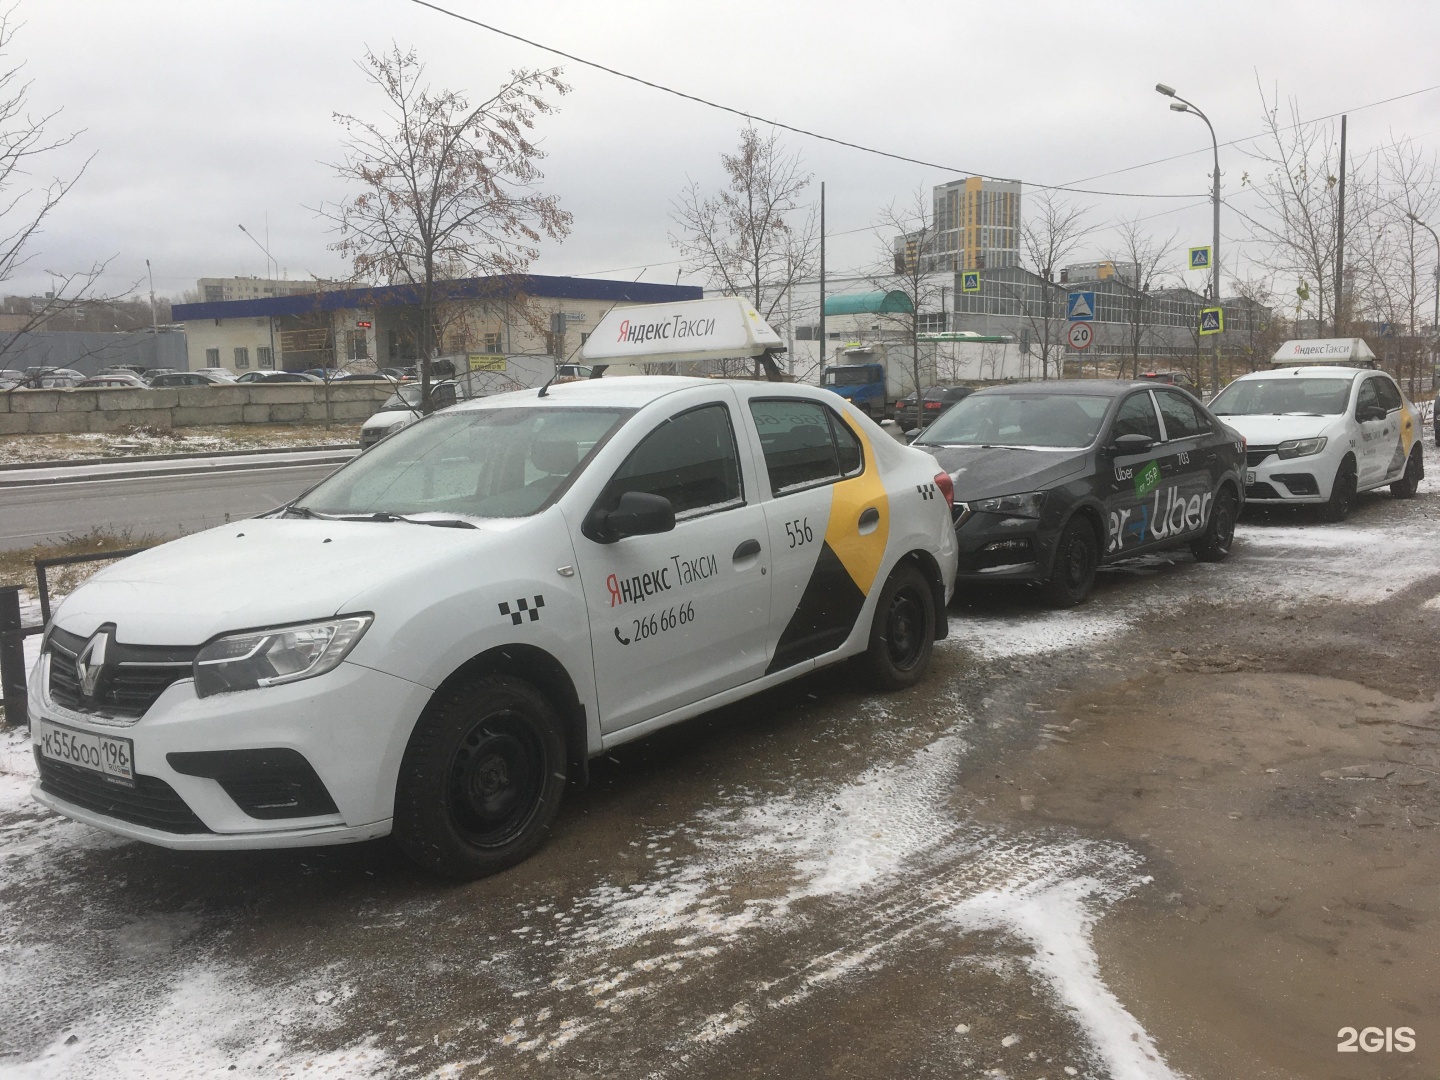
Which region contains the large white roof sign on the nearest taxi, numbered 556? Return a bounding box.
[580,297,785,363]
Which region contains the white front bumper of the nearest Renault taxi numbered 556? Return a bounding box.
[29,654,431,850]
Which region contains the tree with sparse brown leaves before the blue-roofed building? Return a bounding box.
[320,45,572,412]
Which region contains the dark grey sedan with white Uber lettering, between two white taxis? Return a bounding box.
[912,379,1246,608]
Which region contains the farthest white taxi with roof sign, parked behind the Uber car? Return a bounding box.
[1210,338,1426,521]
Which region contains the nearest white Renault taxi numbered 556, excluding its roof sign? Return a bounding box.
[29,376,955,878]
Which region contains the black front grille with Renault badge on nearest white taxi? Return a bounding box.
[46,626,199,720]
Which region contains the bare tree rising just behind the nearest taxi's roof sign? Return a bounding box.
[670,127,819,379]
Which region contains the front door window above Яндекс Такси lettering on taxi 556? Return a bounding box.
[600,403,744,520]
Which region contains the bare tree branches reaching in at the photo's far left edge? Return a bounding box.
[0,7,115,380]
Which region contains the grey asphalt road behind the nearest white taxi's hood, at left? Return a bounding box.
[0,462,337,550]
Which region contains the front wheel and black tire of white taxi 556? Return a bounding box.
[393,675,566,881]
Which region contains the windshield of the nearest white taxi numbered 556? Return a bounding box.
[295,408,631,517]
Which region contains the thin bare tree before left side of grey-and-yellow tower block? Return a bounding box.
[868,187,955,406]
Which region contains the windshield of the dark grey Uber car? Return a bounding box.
[916,393,1110,448]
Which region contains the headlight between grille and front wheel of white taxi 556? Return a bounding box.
[194,615,374,697]
